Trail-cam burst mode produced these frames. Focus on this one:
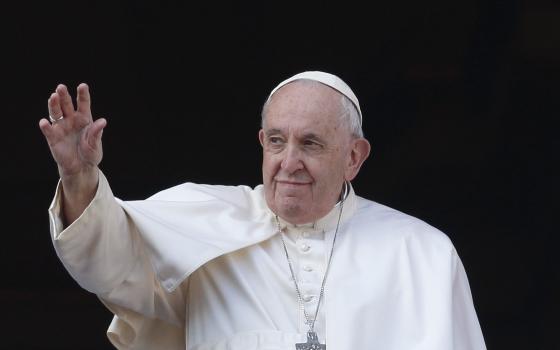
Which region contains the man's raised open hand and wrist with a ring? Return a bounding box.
[39,84,107,223]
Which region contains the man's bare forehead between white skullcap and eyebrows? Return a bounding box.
[265,81,342,130]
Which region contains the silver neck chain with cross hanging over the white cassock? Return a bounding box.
[275,183,348,350]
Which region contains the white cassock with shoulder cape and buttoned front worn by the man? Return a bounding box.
[49,172,486,350]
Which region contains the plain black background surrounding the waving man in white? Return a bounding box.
[0,0,560,350]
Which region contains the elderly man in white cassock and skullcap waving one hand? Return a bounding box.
[39,72,485,350]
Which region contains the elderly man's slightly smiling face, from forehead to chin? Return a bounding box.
[259,81,355,224]
